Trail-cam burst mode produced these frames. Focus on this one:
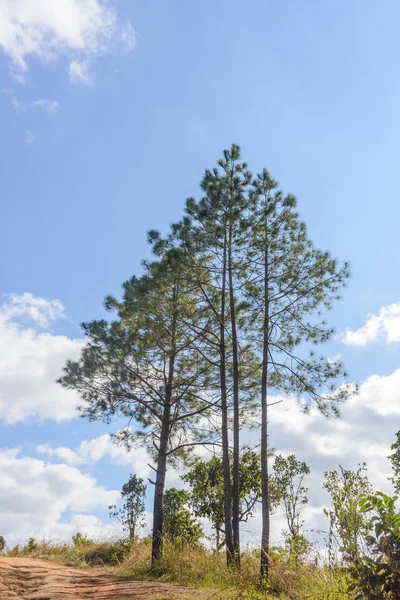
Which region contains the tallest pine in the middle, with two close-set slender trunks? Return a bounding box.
[173,151,252,566]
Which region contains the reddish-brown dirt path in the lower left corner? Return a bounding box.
[0,558,195,600]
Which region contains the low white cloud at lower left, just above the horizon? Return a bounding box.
[0,450,120,544]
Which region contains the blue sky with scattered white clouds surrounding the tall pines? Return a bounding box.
[0,0,400,539]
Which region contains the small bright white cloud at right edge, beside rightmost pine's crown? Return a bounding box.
[342,302,400,346]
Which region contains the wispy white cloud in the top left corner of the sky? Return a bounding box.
[0,0,134,83]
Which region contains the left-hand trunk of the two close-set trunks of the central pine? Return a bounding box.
[219,227,234,566]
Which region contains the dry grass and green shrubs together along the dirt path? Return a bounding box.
[0,434,400,600]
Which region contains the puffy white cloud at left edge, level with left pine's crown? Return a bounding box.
[0,294,84,423]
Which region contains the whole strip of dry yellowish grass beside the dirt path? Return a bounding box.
[3,539,352,600]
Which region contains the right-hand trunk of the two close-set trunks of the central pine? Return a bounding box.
[228,223,240,567]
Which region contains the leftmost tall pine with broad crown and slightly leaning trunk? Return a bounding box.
[60,243,219,563]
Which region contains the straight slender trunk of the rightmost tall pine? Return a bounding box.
[260,200,270,579]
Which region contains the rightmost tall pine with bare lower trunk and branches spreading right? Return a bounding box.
[247,170,349,577]
